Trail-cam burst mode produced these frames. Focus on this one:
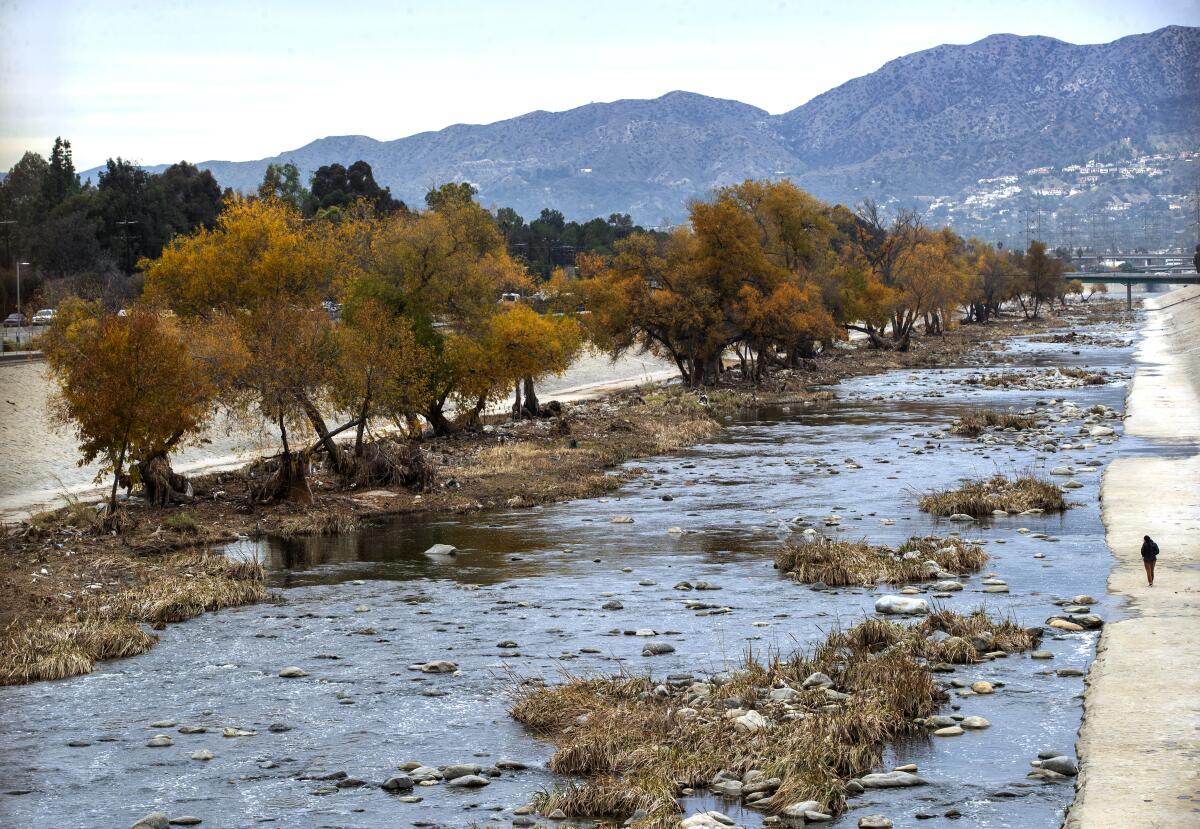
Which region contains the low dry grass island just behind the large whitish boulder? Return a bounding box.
[775,535,988,587]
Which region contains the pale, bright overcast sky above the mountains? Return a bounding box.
[0,0,1200,170]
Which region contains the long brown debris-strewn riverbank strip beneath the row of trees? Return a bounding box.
[0,305,1060,683]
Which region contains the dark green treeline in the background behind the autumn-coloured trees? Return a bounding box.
[0,138,657,314]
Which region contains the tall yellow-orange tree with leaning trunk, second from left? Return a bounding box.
[143,199,348,500]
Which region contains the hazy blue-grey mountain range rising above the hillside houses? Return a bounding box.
[84,26,1200,224]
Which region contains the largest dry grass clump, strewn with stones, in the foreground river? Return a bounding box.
[510,611,1028,829]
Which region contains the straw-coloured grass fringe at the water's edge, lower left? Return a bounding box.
[0,552,268,685]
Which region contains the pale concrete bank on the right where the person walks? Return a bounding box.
[1066,288,1200,829]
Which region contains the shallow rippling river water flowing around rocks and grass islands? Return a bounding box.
[0,311,1157,829]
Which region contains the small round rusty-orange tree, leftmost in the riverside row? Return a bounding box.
[43,299,212,518]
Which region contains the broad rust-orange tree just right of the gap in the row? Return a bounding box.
[577,182,838,386]
